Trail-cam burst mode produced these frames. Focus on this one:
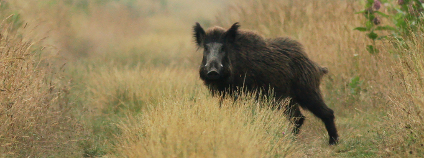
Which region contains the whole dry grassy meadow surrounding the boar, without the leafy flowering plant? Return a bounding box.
[0,0,424,157]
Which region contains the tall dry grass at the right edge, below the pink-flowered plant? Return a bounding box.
[385,32,424,156]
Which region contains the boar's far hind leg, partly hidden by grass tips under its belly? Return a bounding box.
[284,100,305,134]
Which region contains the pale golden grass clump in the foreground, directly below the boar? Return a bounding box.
[111,71,300,157]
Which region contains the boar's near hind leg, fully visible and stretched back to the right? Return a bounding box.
[294,88,339,145]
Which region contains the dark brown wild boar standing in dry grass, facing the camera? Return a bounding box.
[193,23,339,144]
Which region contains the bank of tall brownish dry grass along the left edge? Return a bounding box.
[0,15,81,157]
